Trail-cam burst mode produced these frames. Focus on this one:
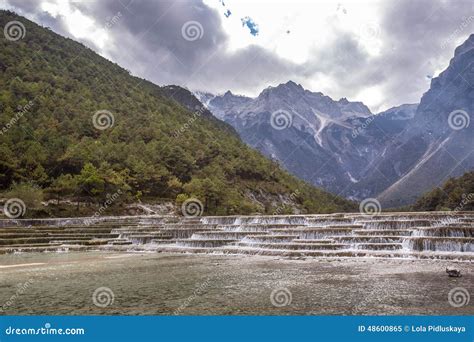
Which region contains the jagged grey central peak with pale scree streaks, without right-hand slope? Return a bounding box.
[196,81,416,198]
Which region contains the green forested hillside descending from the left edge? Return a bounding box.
[0,11,354,214]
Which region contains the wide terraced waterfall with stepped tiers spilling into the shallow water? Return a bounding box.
[0,212,474,260]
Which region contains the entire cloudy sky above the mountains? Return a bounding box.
[0,0,474,112]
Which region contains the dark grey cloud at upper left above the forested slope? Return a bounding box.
[83,0,226,59]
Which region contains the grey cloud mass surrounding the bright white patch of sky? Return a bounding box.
[3,0,474,110]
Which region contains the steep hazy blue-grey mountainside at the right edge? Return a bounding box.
[368,35,474,206]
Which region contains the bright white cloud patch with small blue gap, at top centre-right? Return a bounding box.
[205,0,381,63]
